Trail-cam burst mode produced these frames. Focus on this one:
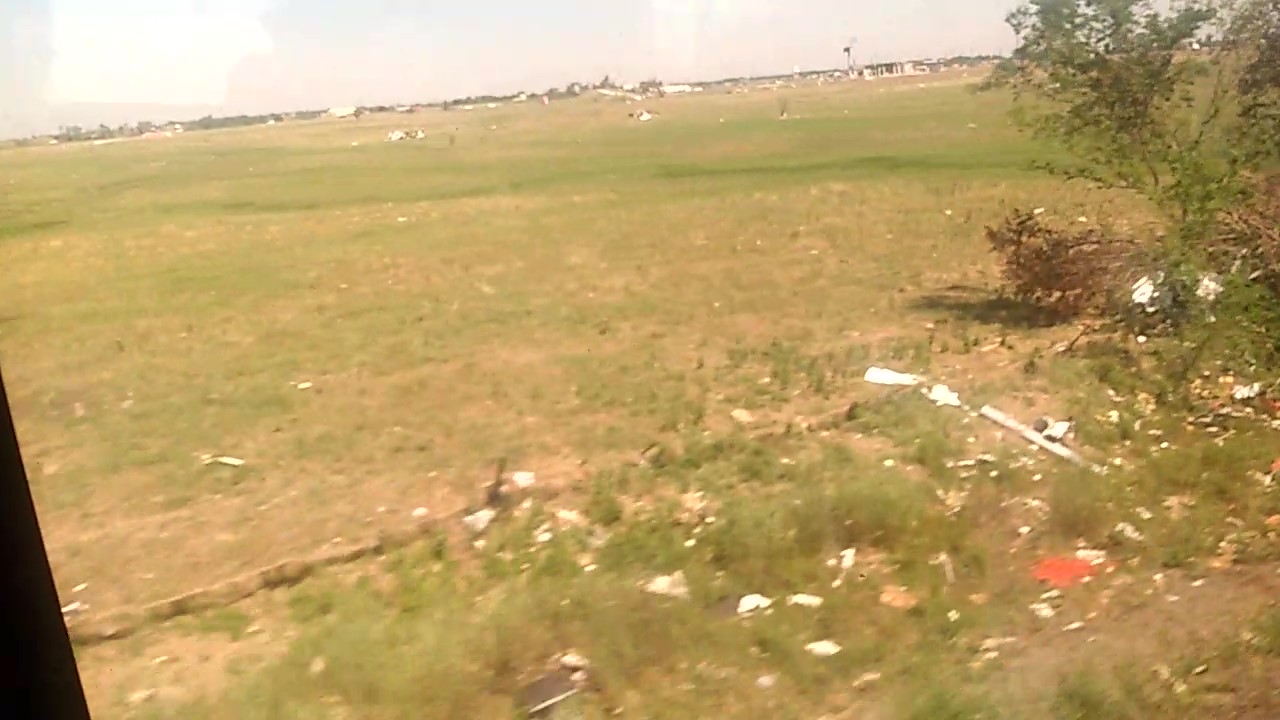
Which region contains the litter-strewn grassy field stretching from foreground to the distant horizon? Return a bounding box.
[0,76,1280,719]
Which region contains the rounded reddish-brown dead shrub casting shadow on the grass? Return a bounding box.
[987,211,1143,320]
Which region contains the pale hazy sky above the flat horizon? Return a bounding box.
[0,0,1016,131]
